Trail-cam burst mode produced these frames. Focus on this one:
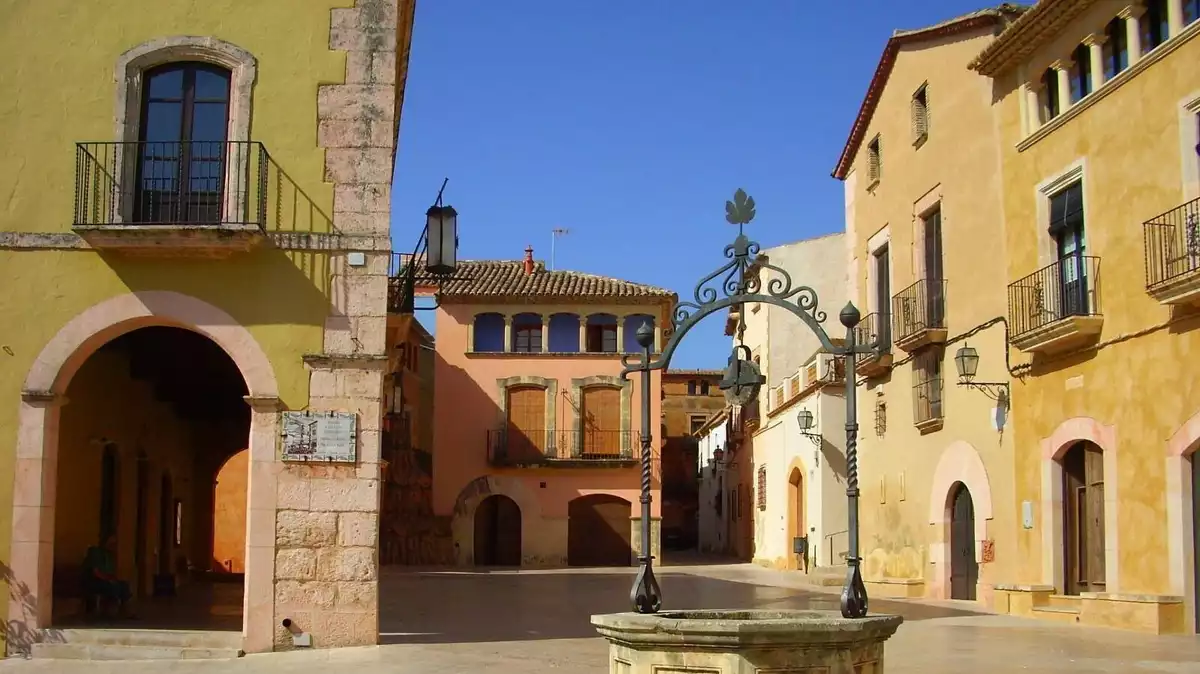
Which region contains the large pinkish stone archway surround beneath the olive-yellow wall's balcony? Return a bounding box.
[8,290,278,650]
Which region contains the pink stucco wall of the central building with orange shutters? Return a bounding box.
[433,305,662,518]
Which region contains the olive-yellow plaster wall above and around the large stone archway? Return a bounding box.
[0,0,352,638]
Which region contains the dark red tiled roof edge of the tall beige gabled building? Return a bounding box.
[833,2,1027,180]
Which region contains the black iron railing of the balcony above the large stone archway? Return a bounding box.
[74,140,269,229]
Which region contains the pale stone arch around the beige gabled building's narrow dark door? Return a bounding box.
[929,440,992,598]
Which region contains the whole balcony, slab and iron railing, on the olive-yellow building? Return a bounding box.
[72,140,270,255]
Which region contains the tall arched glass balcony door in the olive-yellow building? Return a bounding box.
[134,62,236,224]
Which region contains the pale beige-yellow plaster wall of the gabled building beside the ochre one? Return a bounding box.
[846,28,1018,600]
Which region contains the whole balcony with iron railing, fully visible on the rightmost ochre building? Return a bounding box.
[1008,255,1104,354]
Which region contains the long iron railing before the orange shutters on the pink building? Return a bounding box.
[487,427,642,465]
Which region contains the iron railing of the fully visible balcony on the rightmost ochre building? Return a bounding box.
[1008,255,1100,337]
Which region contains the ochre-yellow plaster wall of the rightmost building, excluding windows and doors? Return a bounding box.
[996,18,1200,594]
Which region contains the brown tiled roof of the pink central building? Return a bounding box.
[416,260,676,303]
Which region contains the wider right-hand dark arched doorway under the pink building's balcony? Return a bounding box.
[566,494,634,566]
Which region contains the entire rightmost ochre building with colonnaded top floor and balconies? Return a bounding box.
[964,0,1200,632]
